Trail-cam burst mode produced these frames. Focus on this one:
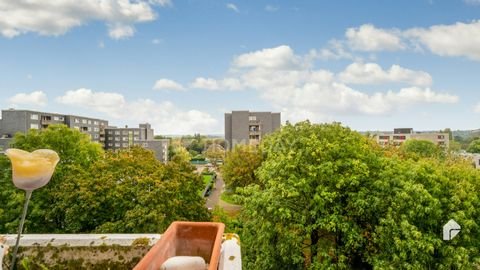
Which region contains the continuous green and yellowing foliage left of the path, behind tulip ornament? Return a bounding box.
[0,126,210,233]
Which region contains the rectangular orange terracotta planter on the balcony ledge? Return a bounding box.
[134,221,225,270]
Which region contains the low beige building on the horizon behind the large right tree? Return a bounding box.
[374,128,450,148]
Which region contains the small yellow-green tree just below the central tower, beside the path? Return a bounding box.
[222,145,263,191]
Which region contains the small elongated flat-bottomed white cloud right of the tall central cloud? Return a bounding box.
[338,62,432,86]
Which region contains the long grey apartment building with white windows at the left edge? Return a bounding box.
[0,109,108,145]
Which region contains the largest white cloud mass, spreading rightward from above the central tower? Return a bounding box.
[188,46,458,121]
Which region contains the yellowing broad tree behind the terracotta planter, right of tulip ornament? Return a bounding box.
[55,147,210,233]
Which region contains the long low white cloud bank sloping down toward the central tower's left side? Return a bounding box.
[56,88,219,134]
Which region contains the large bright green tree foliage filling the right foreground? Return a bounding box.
[241,122,480,269]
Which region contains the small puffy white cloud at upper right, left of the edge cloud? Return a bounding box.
[345,24,405,51]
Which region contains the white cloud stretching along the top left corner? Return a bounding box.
[0,0,167,39]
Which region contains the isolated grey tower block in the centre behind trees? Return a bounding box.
[225,111,280,149]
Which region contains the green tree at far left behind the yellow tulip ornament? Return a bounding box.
[0,125,103,233]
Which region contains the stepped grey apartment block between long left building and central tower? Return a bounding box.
[105,123,169,162]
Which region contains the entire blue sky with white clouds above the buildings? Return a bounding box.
[0,0,480,134]
